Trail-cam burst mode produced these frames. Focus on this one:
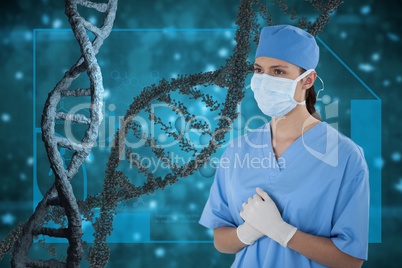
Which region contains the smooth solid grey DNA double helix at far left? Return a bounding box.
[12,0,117,268]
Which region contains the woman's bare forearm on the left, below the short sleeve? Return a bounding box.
[214,226,247,254]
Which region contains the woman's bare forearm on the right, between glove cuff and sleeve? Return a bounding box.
[287,230,363,268]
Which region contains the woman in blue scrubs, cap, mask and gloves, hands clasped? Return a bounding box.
[200,25,369,268]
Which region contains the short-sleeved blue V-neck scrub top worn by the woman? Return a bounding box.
[200,122,369,268]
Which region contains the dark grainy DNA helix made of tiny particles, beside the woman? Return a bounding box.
[87,0,342,267]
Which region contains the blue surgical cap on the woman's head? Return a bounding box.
[255,25,319,70]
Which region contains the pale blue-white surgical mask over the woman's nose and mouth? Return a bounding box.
[251,69,314,118]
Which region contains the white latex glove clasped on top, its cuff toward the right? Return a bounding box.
[240,187,297,247]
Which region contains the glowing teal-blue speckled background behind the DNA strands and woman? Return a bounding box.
[0,0,402,267]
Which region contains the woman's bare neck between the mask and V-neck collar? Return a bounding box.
[271,105,320,143]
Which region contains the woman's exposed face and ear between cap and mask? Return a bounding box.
[254,57,317,102]
